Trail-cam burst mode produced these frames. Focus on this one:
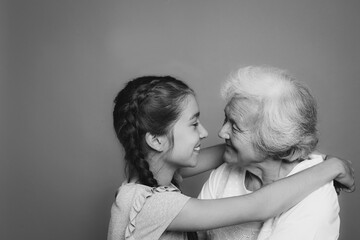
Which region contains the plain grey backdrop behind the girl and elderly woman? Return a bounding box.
[0,0,360,240]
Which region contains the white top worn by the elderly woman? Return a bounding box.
[199,155,340,240]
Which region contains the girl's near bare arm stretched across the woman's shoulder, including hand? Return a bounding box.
[167,158,355,231]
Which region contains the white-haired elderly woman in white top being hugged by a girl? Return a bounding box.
[199,66,340,240]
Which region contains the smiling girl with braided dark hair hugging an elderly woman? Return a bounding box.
[108,76,354,240]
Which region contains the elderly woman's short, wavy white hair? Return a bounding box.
[221,66,318,161]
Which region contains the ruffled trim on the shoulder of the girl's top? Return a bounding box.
[125,185,180,239]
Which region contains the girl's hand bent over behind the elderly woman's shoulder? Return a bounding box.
[325,156,355,195]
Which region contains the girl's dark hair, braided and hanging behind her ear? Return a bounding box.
[113,76,195,187]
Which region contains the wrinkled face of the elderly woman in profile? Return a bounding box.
[219,98,264,167]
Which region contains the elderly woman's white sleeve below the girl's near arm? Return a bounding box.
[264,182,340,240]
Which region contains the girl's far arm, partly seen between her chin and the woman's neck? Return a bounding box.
[179,144,225,178]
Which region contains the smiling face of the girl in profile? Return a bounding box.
[167,95,208,168]
